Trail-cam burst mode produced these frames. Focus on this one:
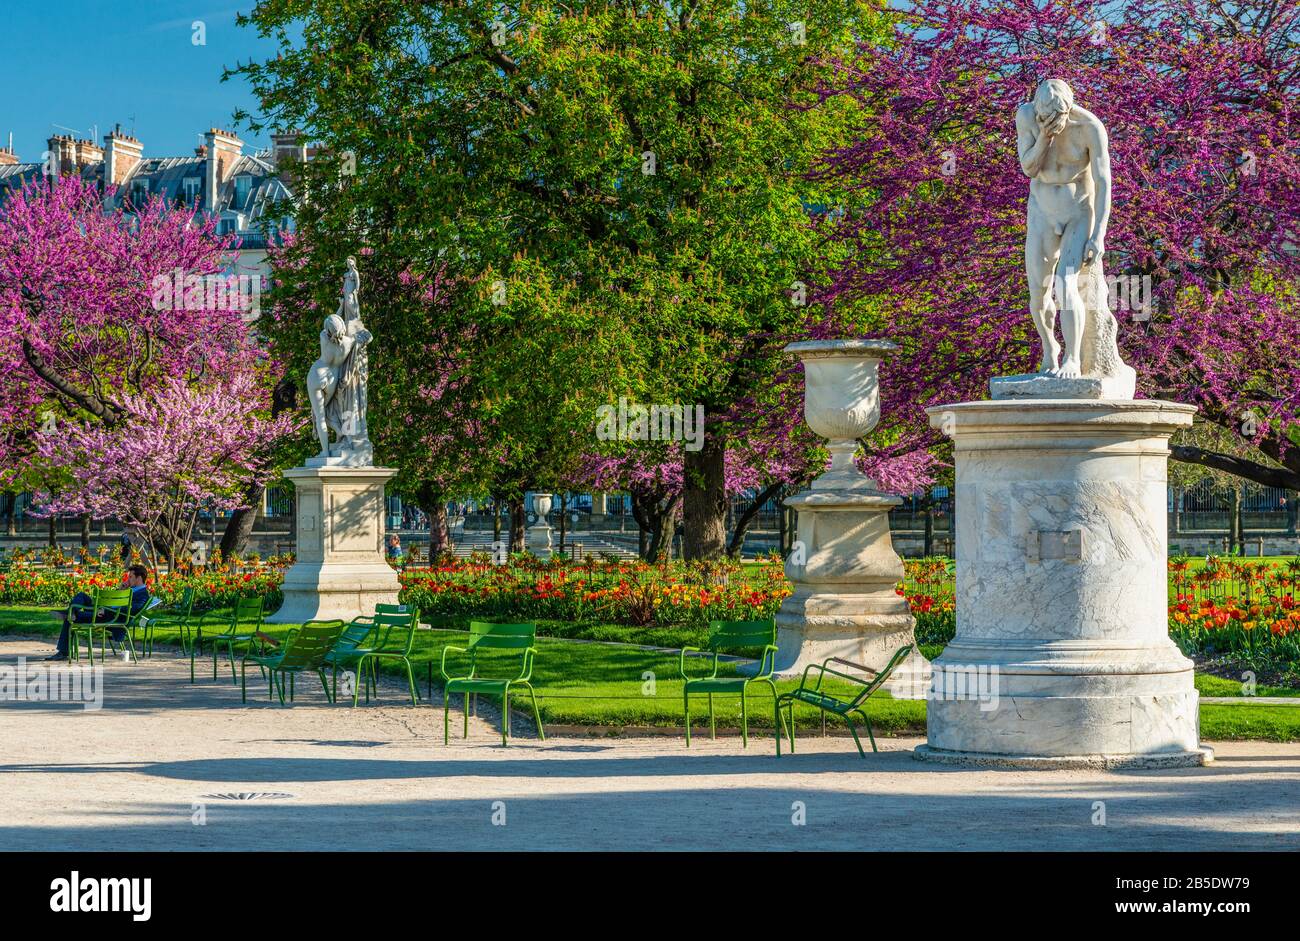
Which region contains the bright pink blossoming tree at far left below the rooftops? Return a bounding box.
[0,177,260,485]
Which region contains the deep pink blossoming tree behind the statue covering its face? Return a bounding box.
[818,0,1300,489]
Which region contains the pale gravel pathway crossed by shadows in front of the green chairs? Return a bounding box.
[0,641,1300,850]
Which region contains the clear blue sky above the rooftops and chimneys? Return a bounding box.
[0,0,283,162]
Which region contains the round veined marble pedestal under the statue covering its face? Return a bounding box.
[917,398,1209,767]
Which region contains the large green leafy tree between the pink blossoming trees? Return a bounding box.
[235,0,878,558]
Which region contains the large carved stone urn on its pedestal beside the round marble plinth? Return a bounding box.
[776,339,930,699]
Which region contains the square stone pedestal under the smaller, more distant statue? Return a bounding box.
[267,465,400,624]
